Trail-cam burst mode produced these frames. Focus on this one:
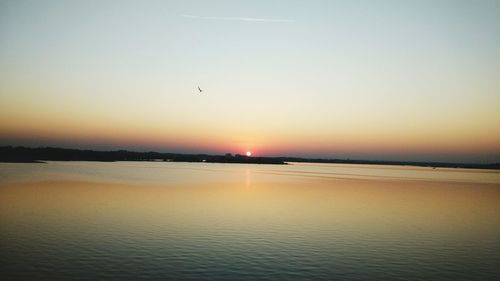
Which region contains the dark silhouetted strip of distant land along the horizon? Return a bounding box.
[0,146,500,170]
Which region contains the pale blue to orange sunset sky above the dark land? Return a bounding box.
[0,0,500,163]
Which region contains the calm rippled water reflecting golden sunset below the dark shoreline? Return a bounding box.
[0,162,500,280]
